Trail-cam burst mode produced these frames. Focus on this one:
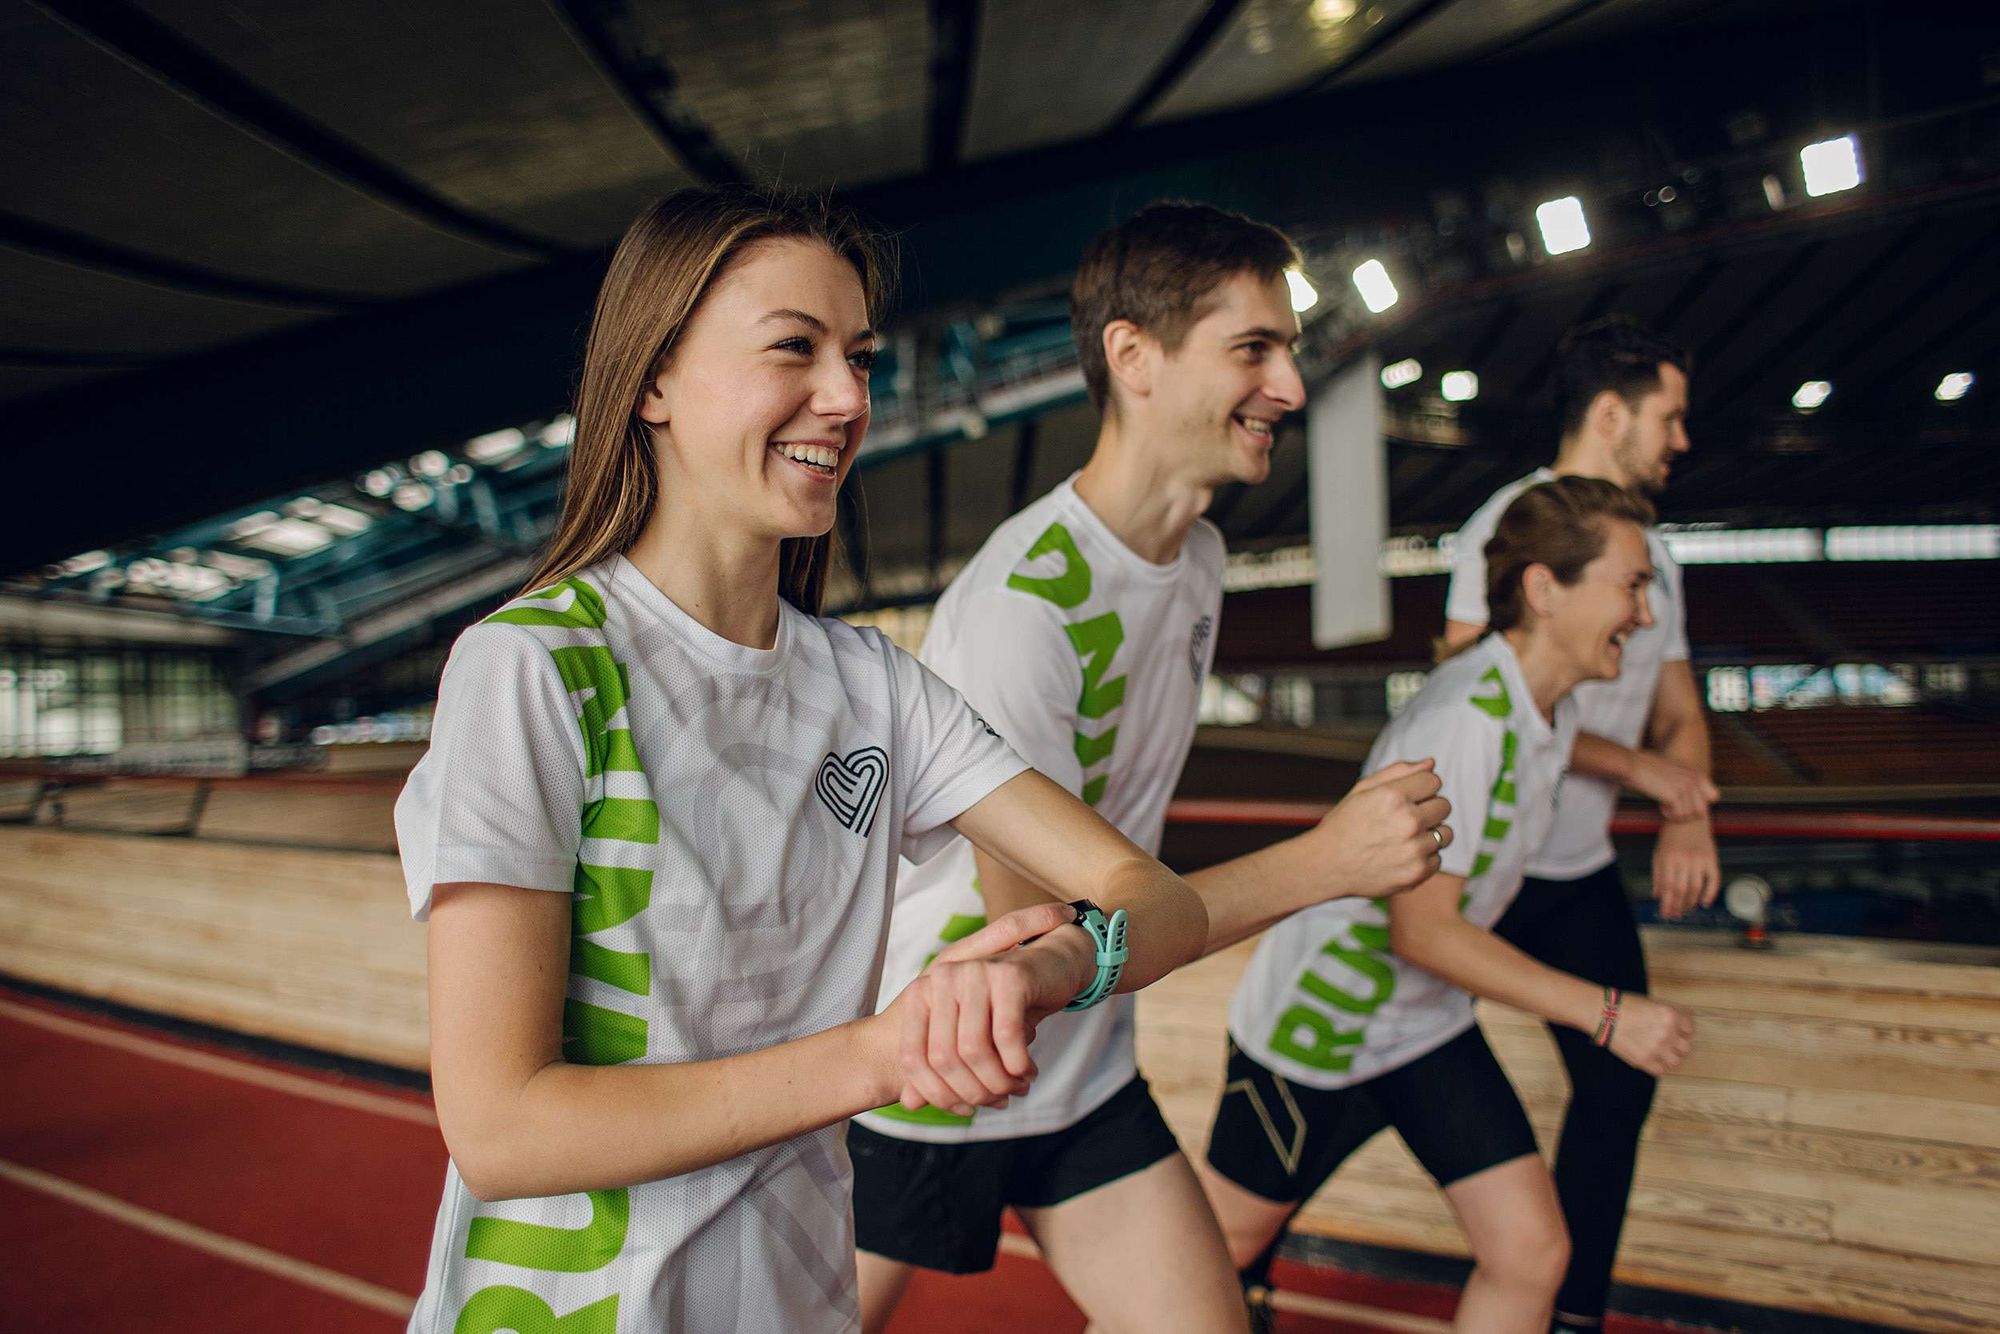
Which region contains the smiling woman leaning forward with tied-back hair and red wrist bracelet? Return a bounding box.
[1202,476,1694,1334]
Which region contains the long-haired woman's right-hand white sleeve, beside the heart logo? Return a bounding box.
[882,640,1028,862]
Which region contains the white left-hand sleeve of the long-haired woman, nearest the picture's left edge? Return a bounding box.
[396,624,584,920]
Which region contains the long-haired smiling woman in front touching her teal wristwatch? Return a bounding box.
[396,190,1206,1334]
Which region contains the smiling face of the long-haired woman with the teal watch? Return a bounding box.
[638,238,874,538]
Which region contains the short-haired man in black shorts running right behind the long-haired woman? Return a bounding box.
[848,204,1450,1334]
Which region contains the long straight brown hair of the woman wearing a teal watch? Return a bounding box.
[522,188,890,616]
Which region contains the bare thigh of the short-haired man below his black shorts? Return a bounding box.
[1020,1152,1244,1334]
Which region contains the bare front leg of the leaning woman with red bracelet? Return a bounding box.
[1444,1154,1570,1334]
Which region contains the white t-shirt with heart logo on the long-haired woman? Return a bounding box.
[396,556,1026,1334]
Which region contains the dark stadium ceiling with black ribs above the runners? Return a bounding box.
[0,0,2000,572]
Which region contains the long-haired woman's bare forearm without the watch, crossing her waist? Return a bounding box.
[454,1018,902,1200]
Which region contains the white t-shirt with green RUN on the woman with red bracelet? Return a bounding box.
[1230,634,1578,1088]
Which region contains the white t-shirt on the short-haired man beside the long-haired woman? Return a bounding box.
[860,478,1222,1142]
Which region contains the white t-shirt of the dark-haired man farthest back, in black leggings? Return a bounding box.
[1444,468,1688,880]
